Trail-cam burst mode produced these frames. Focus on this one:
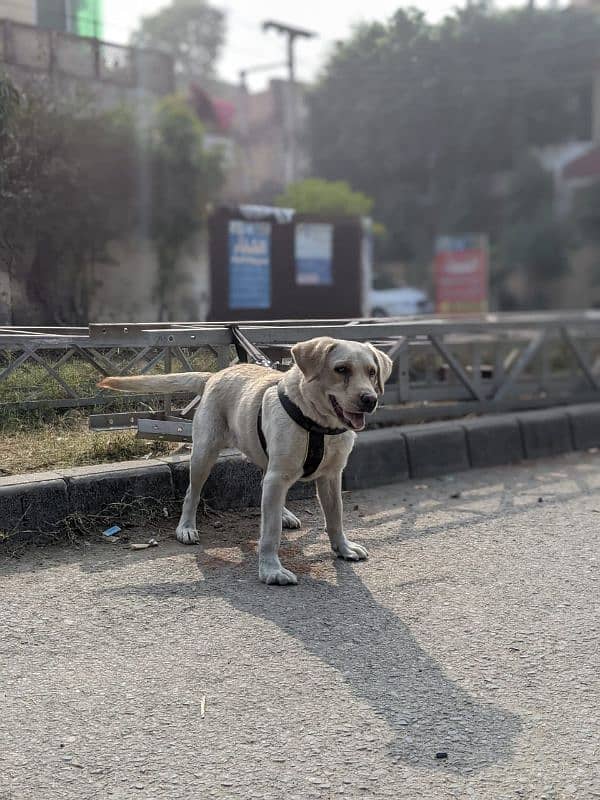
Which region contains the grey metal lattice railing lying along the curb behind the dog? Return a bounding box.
[0,311,600,427]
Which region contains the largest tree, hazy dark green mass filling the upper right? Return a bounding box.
[309,6,600,280]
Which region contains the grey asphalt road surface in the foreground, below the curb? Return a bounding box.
[0,454,600,800]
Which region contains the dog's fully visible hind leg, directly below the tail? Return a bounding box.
[176,410,224,544]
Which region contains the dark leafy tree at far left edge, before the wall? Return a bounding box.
[0,82,136,323]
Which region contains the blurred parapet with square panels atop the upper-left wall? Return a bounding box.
[0,19,175,95]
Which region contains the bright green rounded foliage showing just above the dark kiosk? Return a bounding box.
[275,178,373,217]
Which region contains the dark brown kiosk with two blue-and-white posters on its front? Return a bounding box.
[208,206,371,321]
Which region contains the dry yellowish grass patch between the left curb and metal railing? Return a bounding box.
[0,411,177,475]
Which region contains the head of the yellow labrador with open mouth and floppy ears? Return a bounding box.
[292,336,392,431]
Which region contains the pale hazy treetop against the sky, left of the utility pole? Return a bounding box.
[131,0,225,78]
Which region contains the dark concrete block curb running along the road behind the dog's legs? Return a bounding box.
[0,403,600,541]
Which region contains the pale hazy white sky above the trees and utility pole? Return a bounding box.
[104,0,552,88]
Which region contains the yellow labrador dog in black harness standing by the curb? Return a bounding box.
[99,336,392,585]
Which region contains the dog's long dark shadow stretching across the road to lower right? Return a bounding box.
[113,520,520,772]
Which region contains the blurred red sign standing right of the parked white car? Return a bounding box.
[434,234,489,314]
